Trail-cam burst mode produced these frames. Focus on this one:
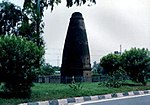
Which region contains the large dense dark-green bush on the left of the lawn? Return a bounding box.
[0,35,44,97]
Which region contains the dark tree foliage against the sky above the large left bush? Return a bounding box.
[0,1,44,46]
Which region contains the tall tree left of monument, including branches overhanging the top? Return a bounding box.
[20,0,96,45]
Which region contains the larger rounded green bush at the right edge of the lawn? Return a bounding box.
[122,48,150,85]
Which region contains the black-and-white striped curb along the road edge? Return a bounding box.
[19,90,150,105]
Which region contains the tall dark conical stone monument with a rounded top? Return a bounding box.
[61,12,91,83]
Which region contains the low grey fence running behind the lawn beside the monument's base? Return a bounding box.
[35,75,108,83]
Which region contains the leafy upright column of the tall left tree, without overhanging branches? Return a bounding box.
[22,0,46,46]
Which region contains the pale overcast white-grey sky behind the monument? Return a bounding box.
[3,0,150,66]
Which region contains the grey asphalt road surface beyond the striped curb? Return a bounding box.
[81,95,150,105]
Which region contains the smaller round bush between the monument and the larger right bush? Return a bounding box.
[100,53,121,76]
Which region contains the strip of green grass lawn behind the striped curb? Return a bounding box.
[0,82,150,105]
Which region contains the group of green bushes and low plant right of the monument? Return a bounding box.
[100,48,150,87]
